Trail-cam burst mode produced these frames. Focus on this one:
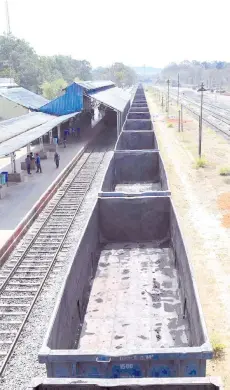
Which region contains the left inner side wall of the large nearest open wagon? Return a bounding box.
[48,205,99,349]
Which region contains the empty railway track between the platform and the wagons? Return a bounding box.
[0,134,110,375]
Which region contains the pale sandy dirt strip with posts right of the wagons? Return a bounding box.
[146,90,230,390]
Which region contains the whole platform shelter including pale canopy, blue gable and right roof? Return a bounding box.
[0,81,130,186]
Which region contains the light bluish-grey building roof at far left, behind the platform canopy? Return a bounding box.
[0,84,49,109]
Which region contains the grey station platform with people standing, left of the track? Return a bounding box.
[0,118,103,257]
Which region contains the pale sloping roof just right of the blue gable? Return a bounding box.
[87,87,131,112]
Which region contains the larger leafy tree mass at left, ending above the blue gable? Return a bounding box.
[0,35,92,95]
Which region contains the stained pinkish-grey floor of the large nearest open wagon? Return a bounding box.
[78,243,189,354]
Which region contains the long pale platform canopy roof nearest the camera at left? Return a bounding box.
[0,112,79,158]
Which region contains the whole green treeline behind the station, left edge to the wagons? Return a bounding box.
[0,35,136,95]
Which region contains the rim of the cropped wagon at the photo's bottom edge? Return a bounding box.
[27,377,223,390]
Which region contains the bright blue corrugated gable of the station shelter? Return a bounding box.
[38,83,83,116]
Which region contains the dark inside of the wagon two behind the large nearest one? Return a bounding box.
[115,130,158,151]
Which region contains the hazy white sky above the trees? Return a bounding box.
[0,0,230,67]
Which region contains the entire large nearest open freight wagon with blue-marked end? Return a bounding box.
[39,197,212,378]
